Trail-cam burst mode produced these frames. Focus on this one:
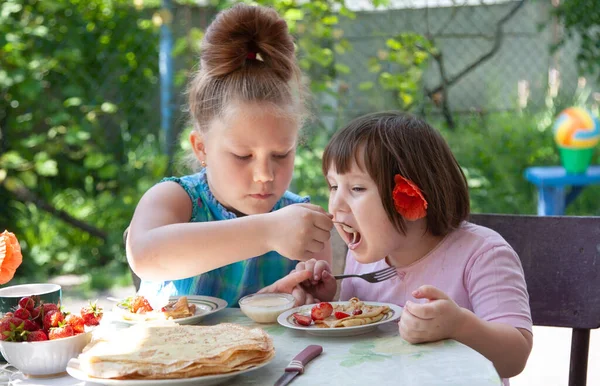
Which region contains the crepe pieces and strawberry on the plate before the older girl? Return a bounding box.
[118,296,196,320]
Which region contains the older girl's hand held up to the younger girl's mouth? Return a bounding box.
[267,204,333,261]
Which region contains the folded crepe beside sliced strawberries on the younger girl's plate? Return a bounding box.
[315,298,391,328]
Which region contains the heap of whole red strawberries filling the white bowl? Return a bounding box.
[0,296,103,342]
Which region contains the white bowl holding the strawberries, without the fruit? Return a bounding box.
[0,331,92,377]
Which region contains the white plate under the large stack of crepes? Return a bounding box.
[67,356,275,386]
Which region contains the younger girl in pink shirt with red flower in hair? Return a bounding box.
[266,113,533,383]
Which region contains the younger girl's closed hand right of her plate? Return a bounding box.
[398,285,465,344]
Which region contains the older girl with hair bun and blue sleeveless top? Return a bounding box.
[127,4,333,306]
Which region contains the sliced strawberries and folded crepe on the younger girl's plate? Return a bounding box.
[292,298,391,328]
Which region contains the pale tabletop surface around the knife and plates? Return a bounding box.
[4,308,502,386]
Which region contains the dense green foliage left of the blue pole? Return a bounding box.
[0,0,167,279]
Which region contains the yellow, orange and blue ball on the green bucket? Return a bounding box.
[553,107,600,149]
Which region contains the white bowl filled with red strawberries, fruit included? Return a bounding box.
[0,296,102,377]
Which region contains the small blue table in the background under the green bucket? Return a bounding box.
[525,165,600,216]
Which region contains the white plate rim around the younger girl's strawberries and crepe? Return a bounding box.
[277,302,402,336]
